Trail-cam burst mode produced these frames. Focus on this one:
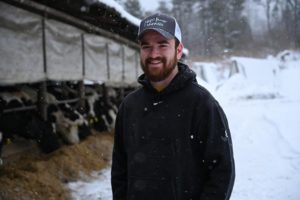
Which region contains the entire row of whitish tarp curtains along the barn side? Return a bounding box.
[0,2,141,85]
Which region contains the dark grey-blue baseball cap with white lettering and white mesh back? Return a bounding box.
[138,13,181,43]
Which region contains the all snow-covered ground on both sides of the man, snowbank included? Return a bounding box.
[68,52,300,200]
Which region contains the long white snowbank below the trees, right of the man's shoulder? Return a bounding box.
[192,51,300,100]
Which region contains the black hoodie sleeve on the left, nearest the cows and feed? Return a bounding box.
[111,105,127,200]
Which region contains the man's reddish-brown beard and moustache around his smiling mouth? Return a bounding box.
[141,53,177,82]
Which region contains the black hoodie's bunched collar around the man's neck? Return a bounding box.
[138,62,196,94]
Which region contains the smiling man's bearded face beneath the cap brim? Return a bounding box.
[140,30,182,82]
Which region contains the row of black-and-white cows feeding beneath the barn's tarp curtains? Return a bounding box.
[0,83,129,164]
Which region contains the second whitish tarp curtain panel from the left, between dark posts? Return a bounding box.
[45,20,83,81]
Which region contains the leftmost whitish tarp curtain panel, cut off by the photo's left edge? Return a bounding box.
[0,2,45,84]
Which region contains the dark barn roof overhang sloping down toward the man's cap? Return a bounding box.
[4,0,140,46]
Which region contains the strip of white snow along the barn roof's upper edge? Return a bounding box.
[98,0,141,26]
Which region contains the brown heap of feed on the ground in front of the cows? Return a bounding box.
[0,132,113,200]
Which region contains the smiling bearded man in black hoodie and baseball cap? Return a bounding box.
[111,14,235,200]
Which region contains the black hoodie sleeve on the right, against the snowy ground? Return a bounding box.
[201,100,235,200]
